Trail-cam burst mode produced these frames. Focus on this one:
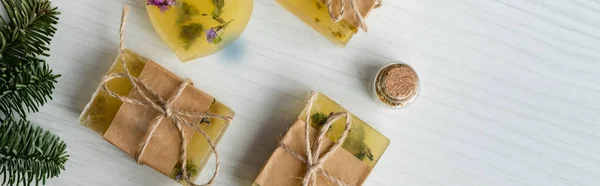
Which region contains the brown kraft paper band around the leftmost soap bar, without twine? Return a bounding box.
[104,61,214,176]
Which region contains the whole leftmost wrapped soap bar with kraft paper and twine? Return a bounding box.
[79,7,234,185]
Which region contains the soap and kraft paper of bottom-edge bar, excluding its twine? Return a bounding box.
[253,93,390,186]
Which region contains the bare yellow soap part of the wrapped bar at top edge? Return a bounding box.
[277,0,357,47]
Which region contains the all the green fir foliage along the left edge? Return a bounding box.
[0,0,68,186]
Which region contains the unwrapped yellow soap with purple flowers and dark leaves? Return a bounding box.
[146,0,253,62]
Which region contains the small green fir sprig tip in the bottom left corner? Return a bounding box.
[0,119,69,186]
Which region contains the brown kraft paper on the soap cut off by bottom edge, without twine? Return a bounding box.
[255,120,371,186]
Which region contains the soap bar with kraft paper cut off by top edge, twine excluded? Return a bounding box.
[277,0,378,46]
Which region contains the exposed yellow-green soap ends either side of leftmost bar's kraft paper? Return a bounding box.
[79,50,234,185]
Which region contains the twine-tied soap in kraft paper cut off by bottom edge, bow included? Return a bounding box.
[254,93,390,186]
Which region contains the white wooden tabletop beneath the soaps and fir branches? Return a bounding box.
[35,0,600,186]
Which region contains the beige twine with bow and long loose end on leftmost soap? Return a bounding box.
[100,5,232,186]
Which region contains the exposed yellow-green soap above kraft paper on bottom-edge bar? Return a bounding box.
[299,93,390,167]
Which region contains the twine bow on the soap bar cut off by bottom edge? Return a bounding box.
[279,92,352,186]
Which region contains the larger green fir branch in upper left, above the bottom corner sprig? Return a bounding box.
[0,0,60,117]
